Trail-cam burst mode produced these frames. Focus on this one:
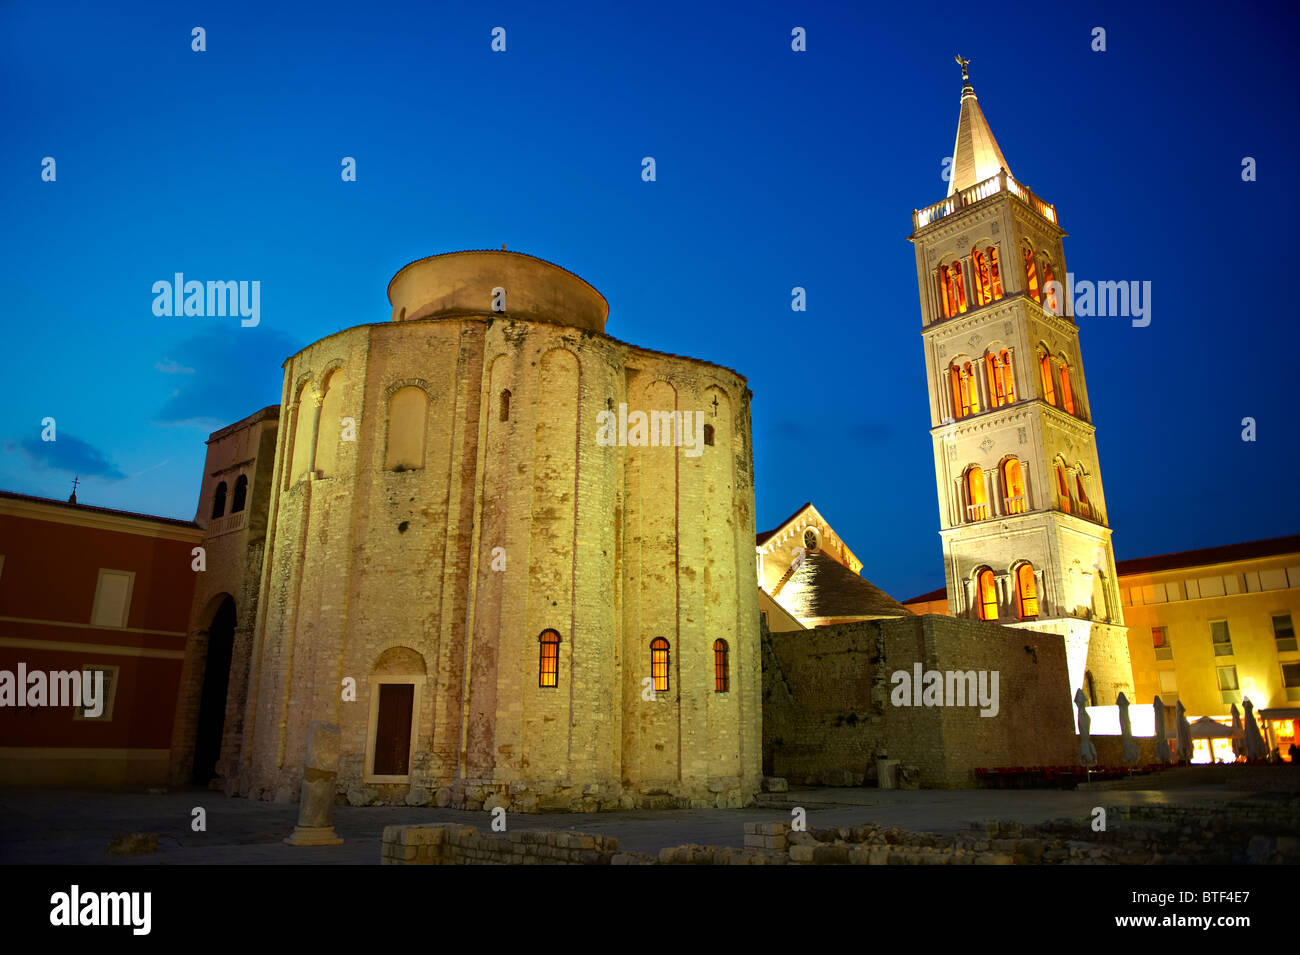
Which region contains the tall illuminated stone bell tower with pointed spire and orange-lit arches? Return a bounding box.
[910,57,1132,706]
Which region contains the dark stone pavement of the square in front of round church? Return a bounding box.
[0,786,1265,865]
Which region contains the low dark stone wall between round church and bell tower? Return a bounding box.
[763,615,1076,789]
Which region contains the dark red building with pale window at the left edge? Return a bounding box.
[0,491,203,786]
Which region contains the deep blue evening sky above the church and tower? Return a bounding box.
[0,0,1300,599]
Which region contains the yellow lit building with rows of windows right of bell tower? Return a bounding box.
[905,535,1300,761]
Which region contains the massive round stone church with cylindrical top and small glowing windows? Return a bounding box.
[230,251,762,811]
